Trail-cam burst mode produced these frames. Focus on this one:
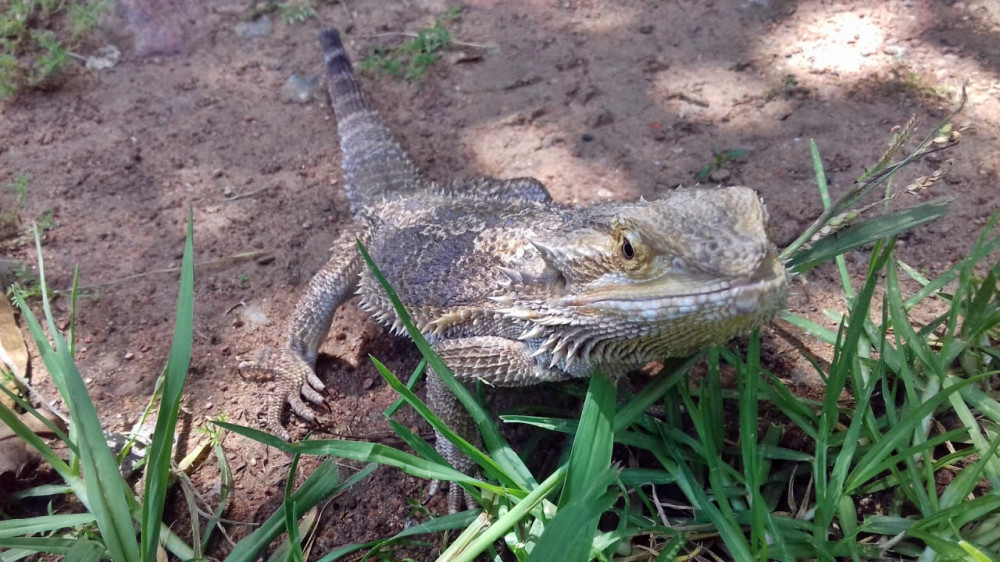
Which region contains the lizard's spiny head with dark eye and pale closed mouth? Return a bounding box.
[531,187,788,355]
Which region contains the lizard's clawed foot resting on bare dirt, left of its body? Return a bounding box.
[238,348,325,441]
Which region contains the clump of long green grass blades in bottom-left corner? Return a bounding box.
[0,219,375,562]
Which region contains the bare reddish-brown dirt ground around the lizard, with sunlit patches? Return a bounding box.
[0,0,1000,558]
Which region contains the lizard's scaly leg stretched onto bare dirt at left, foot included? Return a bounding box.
[249,231,363,441]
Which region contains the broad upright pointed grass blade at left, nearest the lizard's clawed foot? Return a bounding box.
[142,210,194,561]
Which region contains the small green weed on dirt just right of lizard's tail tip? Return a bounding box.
[361,6,461,81]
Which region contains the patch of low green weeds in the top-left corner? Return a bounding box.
[0,0,111,98]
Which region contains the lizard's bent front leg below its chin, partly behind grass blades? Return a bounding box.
[427,336,572,513]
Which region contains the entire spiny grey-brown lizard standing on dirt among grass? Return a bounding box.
[248,25,788,510]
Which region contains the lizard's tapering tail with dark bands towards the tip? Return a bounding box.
[319,28,421,212]
